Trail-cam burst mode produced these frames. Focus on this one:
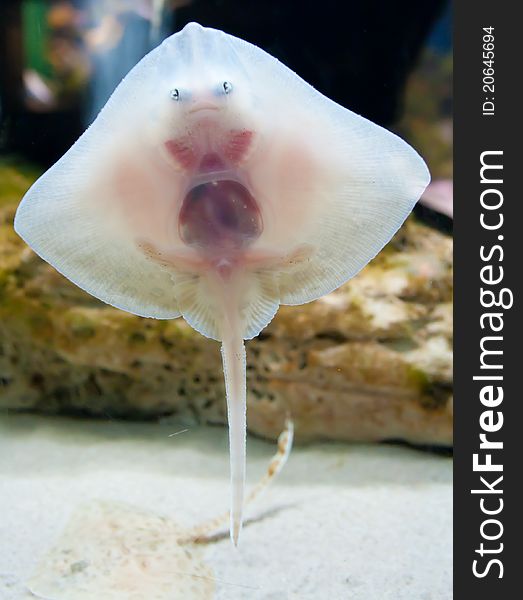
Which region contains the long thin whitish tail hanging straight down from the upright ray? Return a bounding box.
[222,319,247,546]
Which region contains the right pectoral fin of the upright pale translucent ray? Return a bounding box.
[216,25,430,304]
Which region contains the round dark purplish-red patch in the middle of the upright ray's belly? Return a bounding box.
[178,174,263,254]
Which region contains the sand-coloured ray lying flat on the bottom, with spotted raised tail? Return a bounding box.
[27,421,293,600]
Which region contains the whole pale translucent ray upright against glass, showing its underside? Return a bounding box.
[15,23,430,544]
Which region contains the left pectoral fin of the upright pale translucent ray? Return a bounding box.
[15,34,190,319]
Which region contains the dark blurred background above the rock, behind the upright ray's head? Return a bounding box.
[0,0,452,221]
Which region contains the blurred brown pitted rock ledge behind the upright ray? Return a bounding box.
[0,163,452,446]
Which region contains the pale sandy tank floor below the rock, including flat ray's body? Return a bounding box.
[0,416,452,600]
